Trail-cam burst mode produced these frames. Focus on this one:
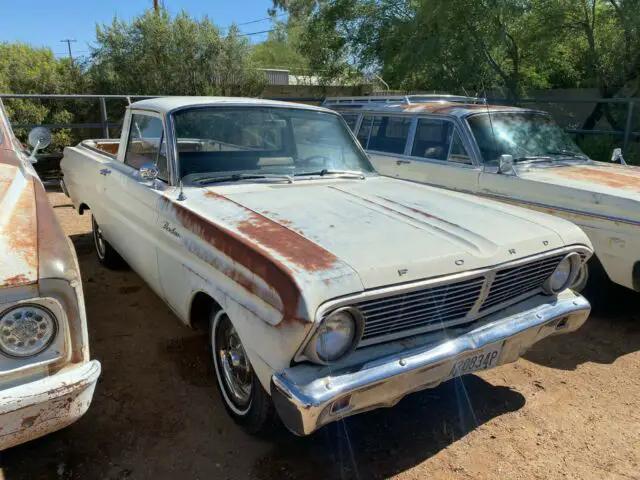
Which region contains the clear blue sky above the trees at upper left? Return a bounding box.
[0,0,282,56]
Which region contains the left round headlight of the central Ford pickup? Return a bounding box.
[310,310,358,363]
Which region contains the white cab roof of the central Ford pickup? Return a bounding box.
[130,97,335,113]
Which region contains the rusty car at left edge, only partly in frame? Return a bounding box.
[0,103,100,450]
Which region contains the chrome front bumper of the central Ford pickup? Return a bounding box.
[271,290,591,435]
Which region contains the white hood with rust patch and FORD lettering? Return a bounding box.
[185,177,588,288]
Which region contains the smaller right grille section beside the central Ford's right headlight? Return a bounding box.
[480,254,566,312]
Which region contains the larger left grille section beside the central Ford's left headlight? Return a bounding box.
[356,276,485,341]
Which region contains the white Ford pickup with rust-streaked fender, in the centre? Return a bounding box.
[61,97,592,435]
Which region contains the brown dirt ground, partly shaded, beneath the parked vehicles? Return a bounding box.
[0,193,640,480]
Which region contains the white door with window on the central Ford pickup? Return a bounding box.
[104,112,169,295]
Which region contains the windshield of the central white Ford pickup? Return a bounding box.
[173,107,374,182]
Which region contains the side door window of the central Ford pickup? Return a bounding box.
[124,113,169,182]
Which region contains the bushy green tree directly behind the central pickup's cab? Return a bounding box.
[88,10,265,96]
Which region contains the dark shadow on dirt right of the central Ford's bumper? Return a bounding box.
[524,285,640,370]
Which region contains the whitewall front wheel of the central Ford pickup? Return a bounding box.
[209,310,277,434]
